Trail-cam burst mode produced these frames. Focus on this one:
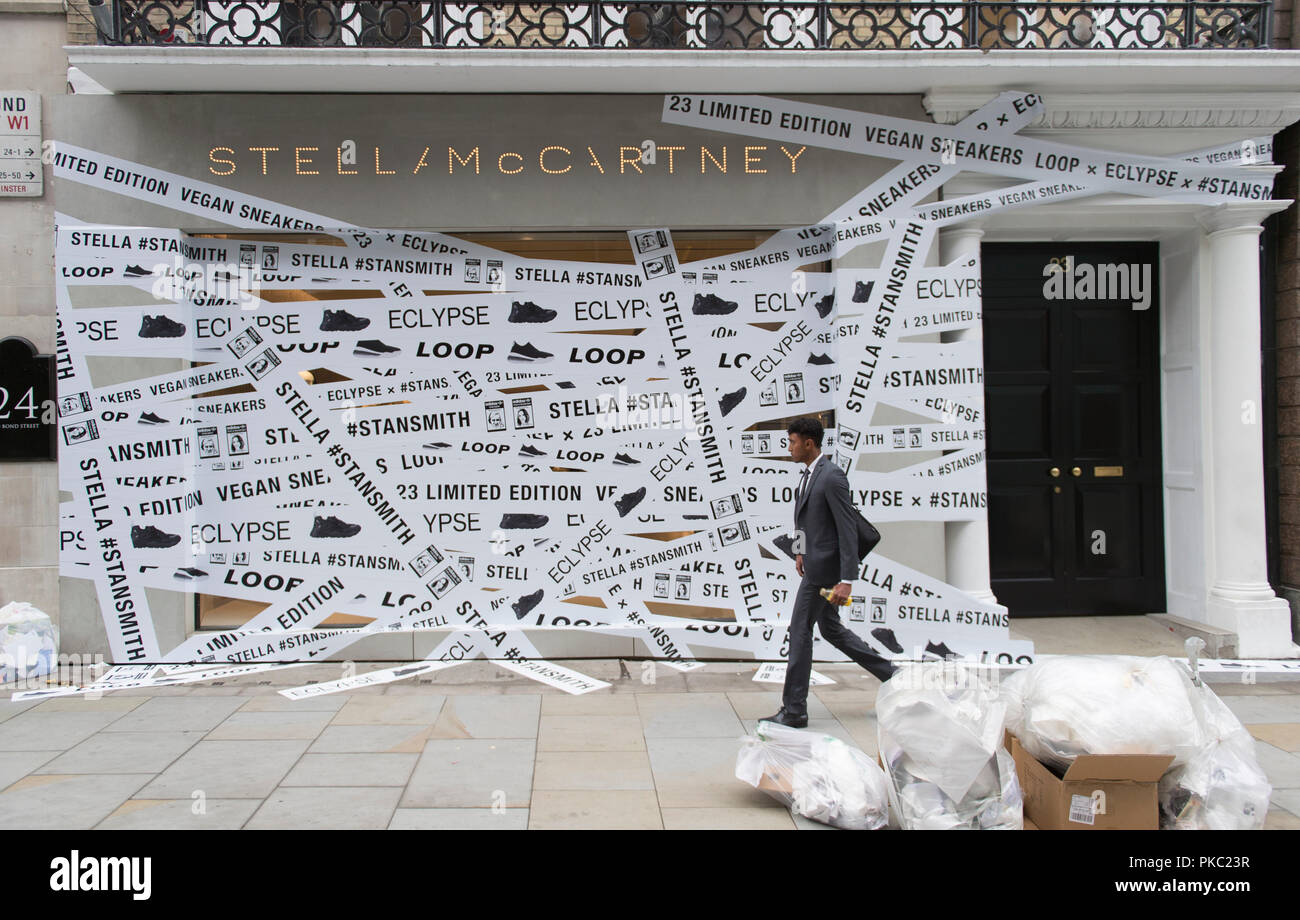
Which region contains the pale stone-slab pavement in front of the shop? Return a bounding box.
[0,617,1300,830]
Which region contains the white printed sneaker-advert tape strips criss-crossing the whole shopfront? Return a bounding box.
[53,92,1271,680]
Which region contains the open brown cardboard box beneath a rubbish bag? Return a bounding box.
[1006,734,1174,830]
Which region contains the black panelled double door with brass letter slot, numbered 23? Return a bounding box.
[982,243,1165,616]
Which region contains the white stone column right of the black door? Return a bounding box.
[1196,203,1295,658]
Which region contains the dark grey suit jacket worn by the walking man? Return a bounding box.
[794,456,859,587]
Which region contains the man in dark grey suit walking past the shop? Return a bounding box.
[766,417,897,728]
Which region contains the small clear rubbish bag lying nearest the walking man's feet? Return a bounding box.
[736,722,889,830]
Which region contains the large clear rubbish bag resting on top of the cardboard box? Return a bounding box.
[1001,655,1201,773]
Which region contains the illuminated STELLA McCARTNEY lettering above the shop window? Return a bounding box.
[205,140,807,177]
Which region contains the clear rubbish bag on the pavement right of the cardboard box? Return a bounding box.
[1160,686,1273,830]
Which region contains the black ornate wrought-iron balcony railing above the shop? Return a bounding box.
[91,0,1273,51]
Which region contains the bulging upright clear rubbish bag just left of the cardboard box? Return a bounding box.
[876,661,1024,830]
